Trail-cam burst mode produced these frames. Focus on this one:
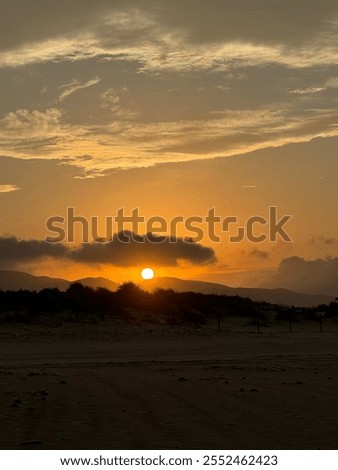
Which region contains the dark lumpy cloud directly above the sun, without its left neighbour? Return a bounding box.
[71,232,216,266]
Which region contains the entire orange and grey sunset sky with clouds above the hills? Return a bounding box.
[0,0,338,295]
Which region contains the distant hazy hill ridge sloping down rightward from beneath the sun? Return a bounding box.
[140,277,333,307]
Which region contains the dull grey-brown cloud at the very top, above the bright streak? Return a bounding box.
[0,0,337,49]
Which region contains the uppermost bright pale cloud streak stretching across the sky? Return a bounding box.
[0,32,338,72]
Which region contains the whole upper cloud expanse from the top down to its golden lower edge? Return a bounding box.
[0,0,338,176]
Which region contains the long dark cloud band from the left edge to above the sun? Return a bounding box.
[0,232,216,268]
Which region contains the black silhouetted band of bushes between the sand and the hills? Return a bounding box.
[0,282,338,331]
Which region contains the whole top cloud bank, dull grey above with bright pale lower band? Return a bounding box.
[0,0,338,71]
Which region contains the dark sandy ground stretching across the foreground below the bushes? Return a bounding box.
[0,320,338,449]
